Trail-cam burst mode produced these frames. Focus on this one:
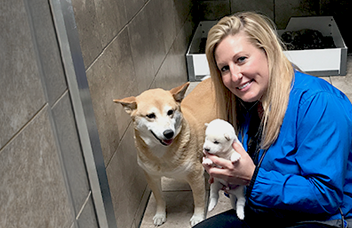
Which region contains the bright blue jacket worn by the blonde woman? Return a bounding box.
[239,72,352,223]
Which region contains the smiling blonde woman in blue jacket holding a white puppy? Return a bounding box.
[196,12,352,228]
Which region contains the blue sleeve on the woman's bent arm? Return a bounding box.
[251,93,352,214]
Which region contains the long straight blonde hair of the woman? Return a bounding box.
[206,12,294,149]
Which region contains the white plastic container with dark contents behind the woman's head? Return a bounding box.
[186,16,347,81]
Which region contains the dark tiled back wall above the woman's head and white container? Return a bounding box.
[198,0,352,29]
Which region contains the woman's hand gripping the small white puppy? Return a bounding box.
[203,142,255,187]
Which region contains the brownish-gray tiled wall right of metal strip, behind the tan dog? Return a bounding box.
[72,0,196,228]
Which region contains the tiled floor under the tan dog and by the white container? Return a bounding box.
[140,55,352,228]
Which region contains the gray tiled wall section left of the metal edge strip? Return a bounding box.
[0,0,97,228]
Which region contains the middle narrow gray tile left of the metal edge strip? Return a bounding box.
[52,93,90,214]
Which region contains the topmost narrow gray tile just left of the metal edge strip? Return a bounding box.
[28,0,67,105]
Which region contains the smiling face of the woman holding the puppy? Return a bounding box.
[215,32,269,102]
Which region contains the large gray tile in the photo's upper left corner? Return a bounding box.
[0,0,45,148]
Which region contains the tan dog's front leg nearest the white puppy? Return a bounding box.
[188,167,205,226]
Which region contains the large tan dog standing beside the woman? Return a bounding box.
[114,79,217,226]
